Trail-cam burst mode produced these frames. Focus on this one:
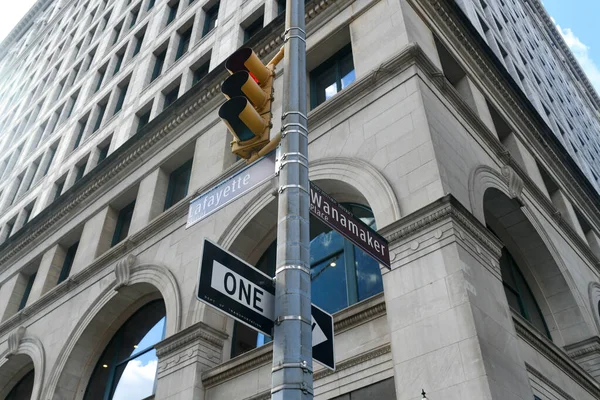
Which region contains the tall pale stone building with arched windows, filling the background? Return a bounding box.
[0,0,600,400]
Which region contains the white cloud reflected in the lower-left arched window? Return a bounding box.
[113,359,157,400]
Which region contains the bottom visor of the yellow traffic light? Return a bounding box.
[219,97,267,142]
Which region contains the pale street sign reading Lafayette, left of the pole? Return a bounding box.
[186,152,275,228]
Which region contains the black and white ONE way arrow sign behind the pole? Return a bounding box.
[197,239,335,370]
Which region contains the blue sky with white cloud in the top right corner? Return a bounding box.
[542,0,600,93]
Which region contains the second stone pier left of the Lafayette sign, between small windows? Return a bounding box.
[71,206,118,275]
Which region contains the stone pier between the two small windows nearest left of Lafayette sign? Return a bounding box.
[129,168,169,235]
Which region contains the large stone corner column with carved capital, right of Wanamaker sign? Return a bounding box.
[381,195,533,400]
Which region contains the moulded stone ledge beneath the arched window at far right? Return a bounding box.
[512,313,600,399]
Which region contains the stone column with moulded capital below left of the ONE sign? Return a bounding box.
[155,322,227,400]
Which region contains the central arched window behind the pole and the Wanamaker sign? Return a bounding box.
[231,203,383,357]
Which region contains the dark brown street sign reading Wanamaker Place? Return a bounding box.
[310,182,391,268]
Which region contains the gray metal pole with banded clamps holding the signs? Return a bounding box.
[271,0,313,400]
